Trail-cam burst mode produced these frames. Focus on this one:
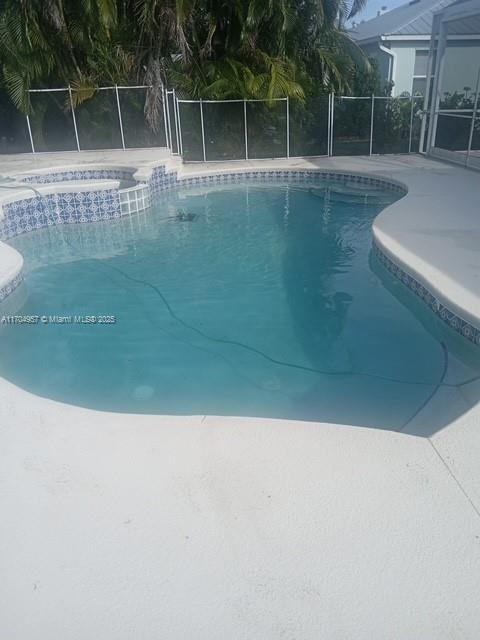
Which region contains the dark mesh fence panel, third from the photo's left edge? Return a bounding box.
[75,89,122,150]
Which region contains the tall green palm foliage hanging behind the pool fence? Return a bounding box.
[0,0,371,128]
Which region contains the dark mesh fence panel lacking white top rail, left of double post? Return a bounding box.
[290,95,329,156]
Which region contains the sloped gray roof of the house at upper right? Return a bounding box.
[350,0,452,42]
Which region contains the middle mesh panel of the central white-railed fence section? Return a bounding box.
[203,102,246,160]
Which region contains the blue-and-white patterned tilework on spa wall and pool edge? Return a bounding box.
[0,164,480,345]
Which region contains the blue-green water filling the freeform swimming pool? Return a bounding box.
[0,183,476,428]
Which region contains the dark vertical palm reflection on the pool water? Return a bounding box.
[283,189,376,371]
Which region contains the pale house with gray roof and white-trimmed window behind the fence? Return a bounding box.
[350,0,458,96]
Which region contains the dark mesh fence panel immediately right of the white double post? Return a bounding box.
[333,98,372,156]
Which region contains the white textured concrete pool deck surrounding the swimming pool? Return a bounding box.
[0,150,480,640]
